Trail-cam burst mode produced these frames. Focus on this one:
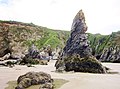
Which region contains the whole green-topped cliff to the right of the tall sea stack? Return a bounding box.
[88,31,120,62]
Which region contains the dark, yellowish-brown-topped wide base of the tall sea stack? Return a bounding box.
[55,55,106,73]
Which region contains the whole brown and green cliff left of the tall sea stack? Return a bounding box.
[0,21,69,57]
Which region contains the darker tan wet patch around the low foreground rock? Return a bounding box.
[5,79,68,89]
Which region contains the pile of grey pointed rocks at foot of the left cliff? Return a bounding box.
[20,44,50,65]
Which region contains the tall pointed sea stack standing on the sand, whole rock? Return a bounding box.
[55,10,106,73]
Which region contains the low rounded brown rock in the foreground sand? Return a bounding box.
[15,72,53,89]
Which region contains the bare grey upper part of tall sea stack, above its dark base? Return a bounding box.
[63,10,91,57]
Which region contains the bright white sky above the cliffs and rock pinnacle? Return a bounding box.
[0,0,120,34]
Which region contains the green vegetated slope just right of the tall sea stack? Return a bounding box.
[88,33,110,54]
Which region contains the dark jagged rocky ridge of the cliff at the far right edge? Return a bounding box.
[99,31,120,63]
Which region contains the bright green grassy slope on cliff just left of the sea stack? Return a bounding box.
[23,28,69,49]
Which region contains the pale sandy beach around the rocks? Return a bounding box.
[0,60,120,89]
